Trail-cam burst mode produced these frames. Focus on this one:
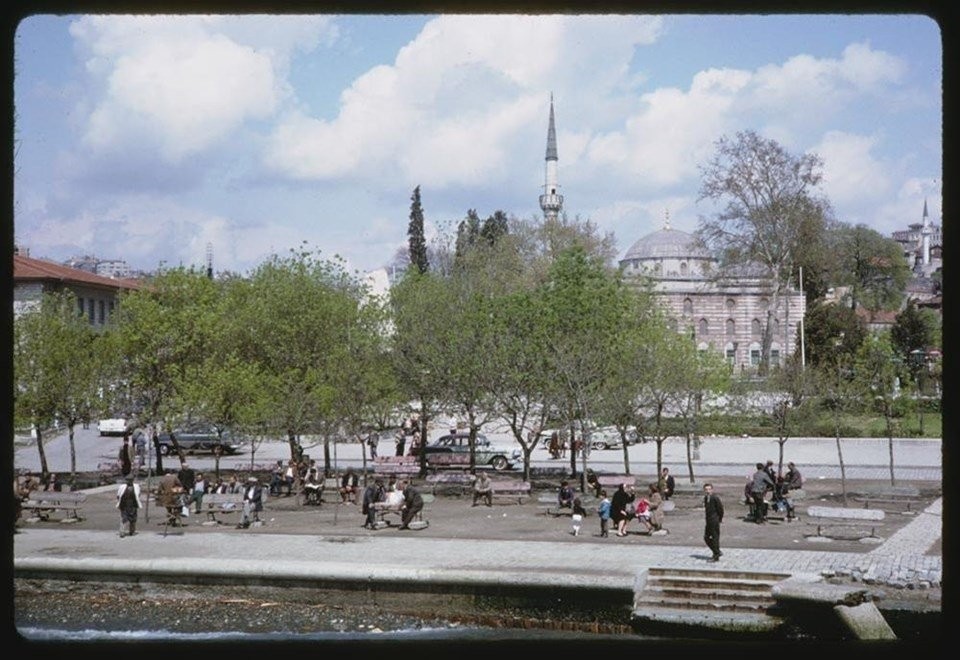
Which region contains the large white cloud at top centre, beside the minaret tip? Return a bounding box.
[264,15,661,187]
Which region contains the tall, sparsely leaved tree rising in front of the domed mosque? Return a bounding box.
[698,131,830,375]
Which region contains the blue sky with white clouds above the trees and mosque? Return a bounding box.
[13,14,943,273]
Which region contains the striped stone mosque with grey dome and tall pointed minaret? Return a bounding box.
[540,97,806,373]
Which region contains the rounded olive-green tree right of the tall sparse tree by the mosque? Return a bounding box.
[831,225,910,311]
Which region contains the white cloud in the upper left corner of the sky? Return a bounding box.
[71,16,329,163]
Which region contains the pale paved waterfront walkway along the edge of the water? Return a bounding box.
[14,500,943,588]
